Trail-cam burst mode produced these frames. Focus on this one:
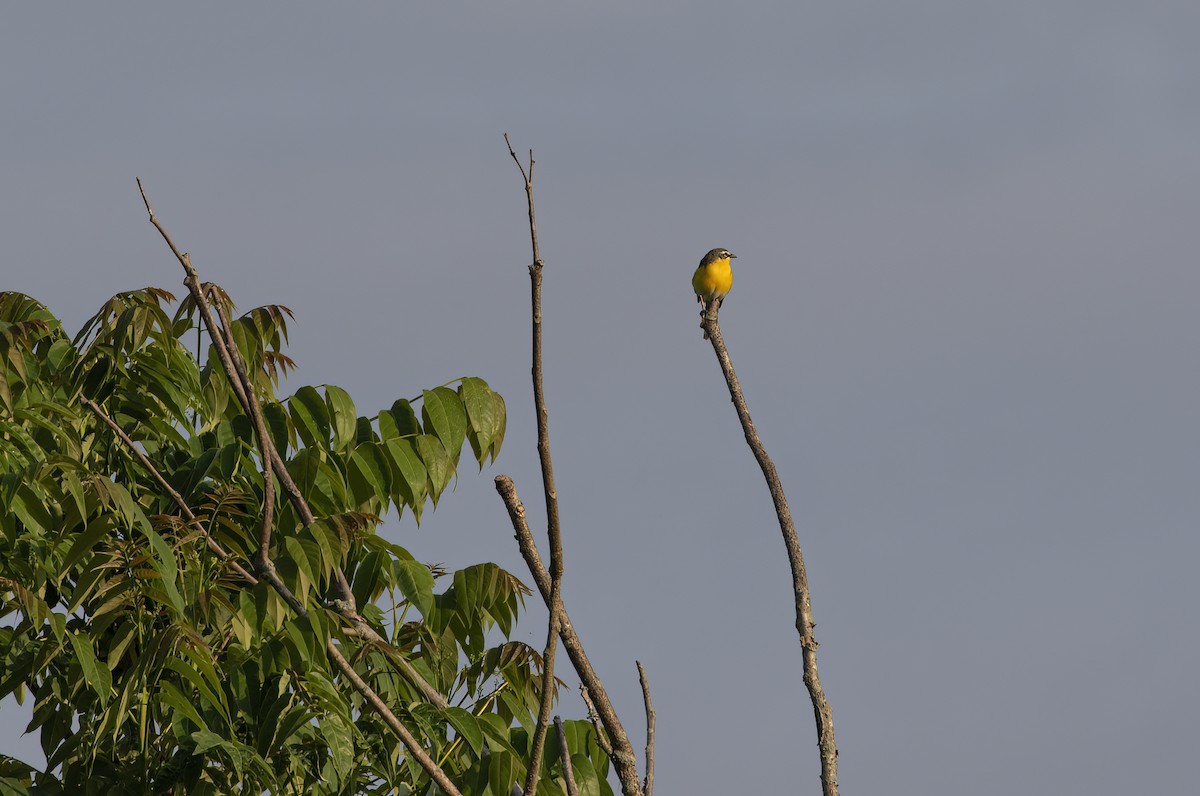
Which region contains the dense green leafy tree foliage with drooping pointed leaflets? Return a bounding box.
[0,286,611,796]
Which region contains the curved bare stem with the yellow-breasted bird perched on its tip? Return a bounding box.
[701,303,838,796]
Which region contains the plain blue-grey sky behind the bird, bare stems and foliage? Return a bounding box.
[0,0,1200,796]
